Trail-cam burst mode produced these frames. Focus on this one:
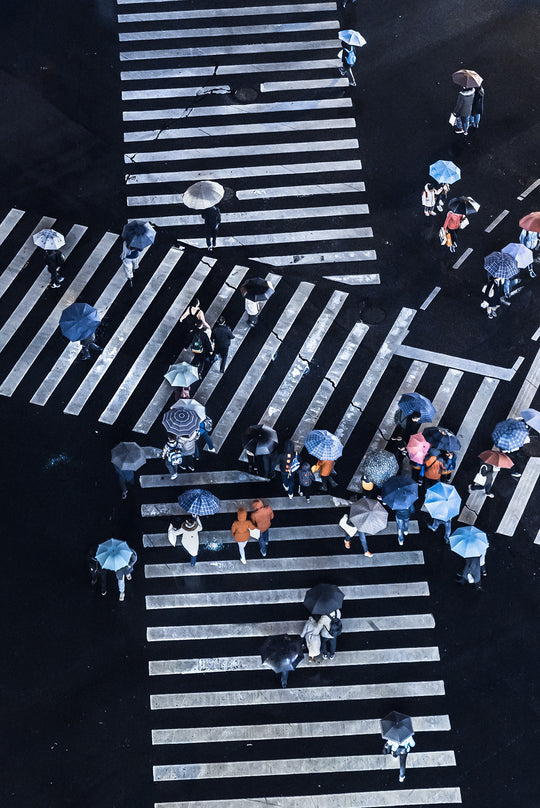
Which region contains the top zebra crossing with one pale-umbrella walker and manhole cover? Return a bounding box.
[118,0,379,274]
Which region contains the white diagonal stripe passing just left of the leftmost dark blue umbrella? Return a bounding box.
[0,233,118,396]
